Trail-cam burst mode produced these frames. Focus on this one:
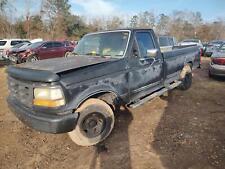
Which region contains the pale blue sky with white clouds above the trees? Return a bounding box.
[14,0,225,21]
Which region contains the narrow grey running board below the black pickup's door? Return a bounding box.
[128,81,181,108]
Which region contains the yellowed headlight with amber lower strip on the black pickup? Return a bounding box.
[33,87,65,107]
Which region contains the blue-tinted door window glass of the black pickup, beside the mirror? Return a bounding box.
[136,32,155,57]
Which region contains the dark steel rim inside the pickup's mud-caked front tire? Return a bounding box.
[82,112,106,138]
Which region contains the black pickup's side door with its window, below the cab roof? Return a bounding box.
[129,31,163,100]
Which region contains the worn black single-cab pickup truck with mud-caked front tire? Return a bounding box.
[7,29,200,146]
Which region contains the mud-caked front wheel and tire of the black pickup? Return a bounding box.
[68,99,115,146]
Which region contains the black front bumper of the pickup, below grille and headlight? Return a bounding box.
[7,97,79,133]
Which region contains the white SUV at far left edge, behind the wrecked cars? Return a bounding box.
[0,39,29,60]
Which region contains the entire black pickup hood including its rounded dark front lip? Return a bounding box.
[7,56,118,82]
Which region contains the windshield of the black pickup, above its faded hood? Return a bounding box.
[73,31,129,58]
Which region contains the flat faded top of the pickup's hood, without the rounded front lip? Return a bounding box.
[19,56,118,74]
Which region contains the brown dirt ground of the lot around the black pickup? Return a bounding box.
[0,59,225,169]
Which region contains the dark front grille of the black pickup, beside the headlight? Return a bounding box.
[8,77,33,107]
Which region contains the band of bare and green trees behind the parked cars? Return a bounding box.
[0,0,225,41]
